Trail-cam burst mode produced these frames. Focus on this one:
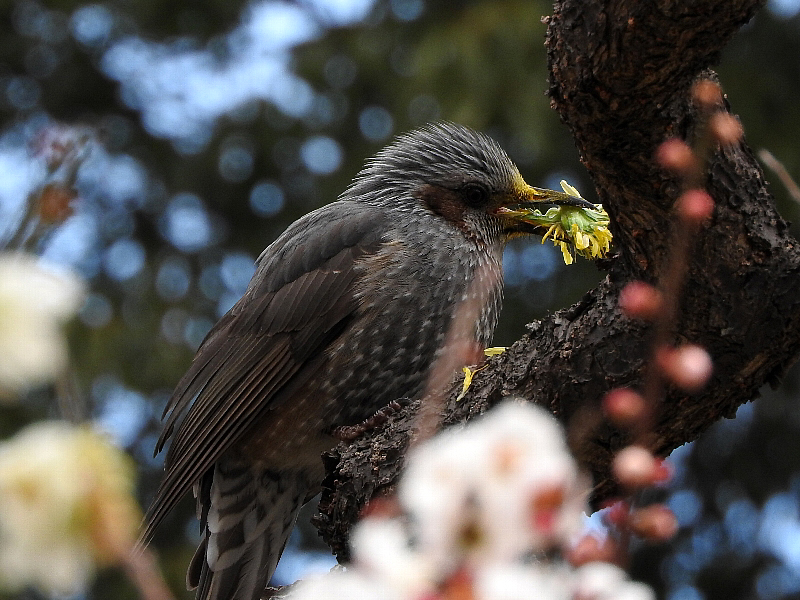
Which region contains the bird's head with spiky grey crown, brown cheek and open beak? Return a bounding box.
[348,123,594,242]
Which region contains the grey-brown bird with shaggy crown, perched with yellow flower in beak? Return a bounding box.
[143,122,592,600]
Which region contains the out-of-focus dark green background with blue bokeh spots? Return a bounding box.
[0,0,800,600]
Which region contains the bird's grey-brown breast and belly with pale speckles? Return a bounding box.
[322,227,502,427]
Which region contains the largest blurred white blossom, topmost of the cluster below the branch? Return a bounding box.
[398,401,588,570]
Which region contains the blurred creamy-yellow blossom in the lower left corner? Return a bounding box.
[0,421,141,594]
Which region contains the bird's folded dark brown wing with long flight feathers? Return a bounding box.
[143,202,386,539]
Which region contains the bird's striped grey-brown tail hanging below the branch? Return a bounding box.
[186,460,309,600]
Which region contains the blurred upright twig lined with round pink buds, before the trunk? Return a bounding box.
[592,81,728,561]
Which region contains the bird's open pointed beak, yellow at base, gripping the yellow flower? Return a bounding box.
[494,177,595,237]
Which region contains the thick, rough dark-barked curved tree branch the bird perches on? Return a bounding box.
[315,0,800,560]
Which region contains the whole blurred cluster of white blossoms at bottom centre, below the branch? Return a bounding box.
[290,401,655,600]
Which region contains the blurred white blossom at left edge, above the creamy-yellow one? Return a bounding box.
[0,253,84,398]
